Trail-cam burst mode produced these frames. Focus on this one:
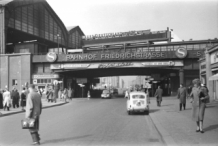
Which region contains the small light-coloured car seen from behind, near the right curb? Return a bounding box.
[127,91,150,115]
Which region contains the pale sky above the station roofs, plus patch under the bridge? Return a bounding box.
[47,0,218,83]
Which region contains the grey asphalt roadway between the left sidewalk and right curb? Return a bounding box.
[0,98,165,146]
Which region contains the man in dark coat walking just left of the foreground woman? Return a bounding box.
[177,84,188,111]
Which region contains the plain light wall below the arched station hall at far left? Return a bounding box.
[0,54,31,91]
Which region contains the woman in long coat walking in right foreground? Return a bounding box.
[190,79,209,133]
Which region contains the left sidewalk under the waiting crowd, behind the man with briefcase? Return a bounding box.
[0,98,66,117]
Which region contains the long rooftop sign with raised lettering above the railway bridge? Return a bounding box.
[82,30,171,47]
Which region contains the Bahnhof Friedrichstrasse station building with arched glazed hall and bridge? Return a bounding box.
[0,0,218,99]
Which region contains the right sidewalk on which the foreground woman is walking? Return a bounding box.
[150,97,218,146]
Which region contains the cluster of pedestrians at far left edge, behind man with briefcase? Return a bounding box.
[0,88,27,111]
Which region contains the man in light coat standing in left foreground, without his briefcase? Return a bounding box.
[25,84,42,145]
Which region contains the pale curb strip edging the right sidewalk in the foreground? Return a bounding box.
[150,111,178,146]
